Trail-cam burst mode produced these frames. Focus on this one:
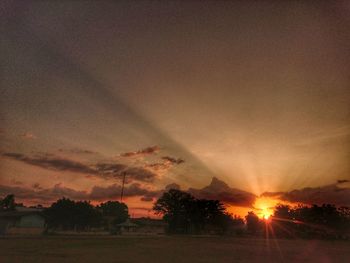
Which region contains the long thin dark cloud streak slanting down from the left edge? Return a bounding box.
[2,153,157,182]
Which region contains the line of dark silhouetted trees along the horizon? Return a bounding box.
[0,189,350,238]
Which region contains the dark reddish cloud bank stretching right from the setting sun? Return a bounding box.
[262,183,350,206]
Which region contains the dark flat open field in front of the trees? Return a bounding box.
[0,236,350,263]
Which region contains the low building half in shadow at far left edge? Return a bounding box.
[0,209,45,235]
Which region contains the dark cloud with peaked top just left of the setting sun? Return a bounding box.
[188,177,256,207]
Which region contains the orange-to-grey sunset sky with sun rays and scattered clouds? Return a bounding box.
[0,1,350,219]
